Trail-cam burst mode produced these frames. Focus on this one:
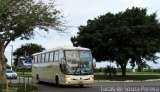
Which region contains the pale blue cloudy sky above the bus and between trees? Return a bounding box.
[5,0,160,68]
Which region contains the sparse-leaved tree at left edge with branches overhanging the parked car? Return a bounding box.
[0,0,65,84]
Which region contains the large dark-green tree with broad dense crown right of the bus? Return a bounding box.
[71,7,160,76]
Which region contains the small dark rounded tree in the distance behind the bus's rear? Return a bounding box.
[13,43,45,66]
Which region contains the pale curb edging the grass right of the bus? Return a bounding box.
[94,79,160,82]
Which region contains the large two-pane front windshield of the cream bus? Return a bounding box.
[65,50,93,75]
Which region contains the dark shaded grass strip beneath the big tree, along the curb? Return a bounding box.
[94,75,160,81]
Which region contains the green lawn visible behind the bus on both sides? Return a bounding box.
[17,72,160,81]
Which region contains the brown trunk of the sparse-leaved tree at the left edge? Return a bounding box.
[0,44,6,85]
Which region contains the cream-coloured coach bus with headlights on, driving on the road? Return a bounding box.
[32,47,95,87]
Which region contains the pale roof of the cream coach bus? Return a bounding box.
[33,46,90,55]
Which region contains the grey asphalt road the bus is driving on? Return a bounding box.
[8,78,160,92]
